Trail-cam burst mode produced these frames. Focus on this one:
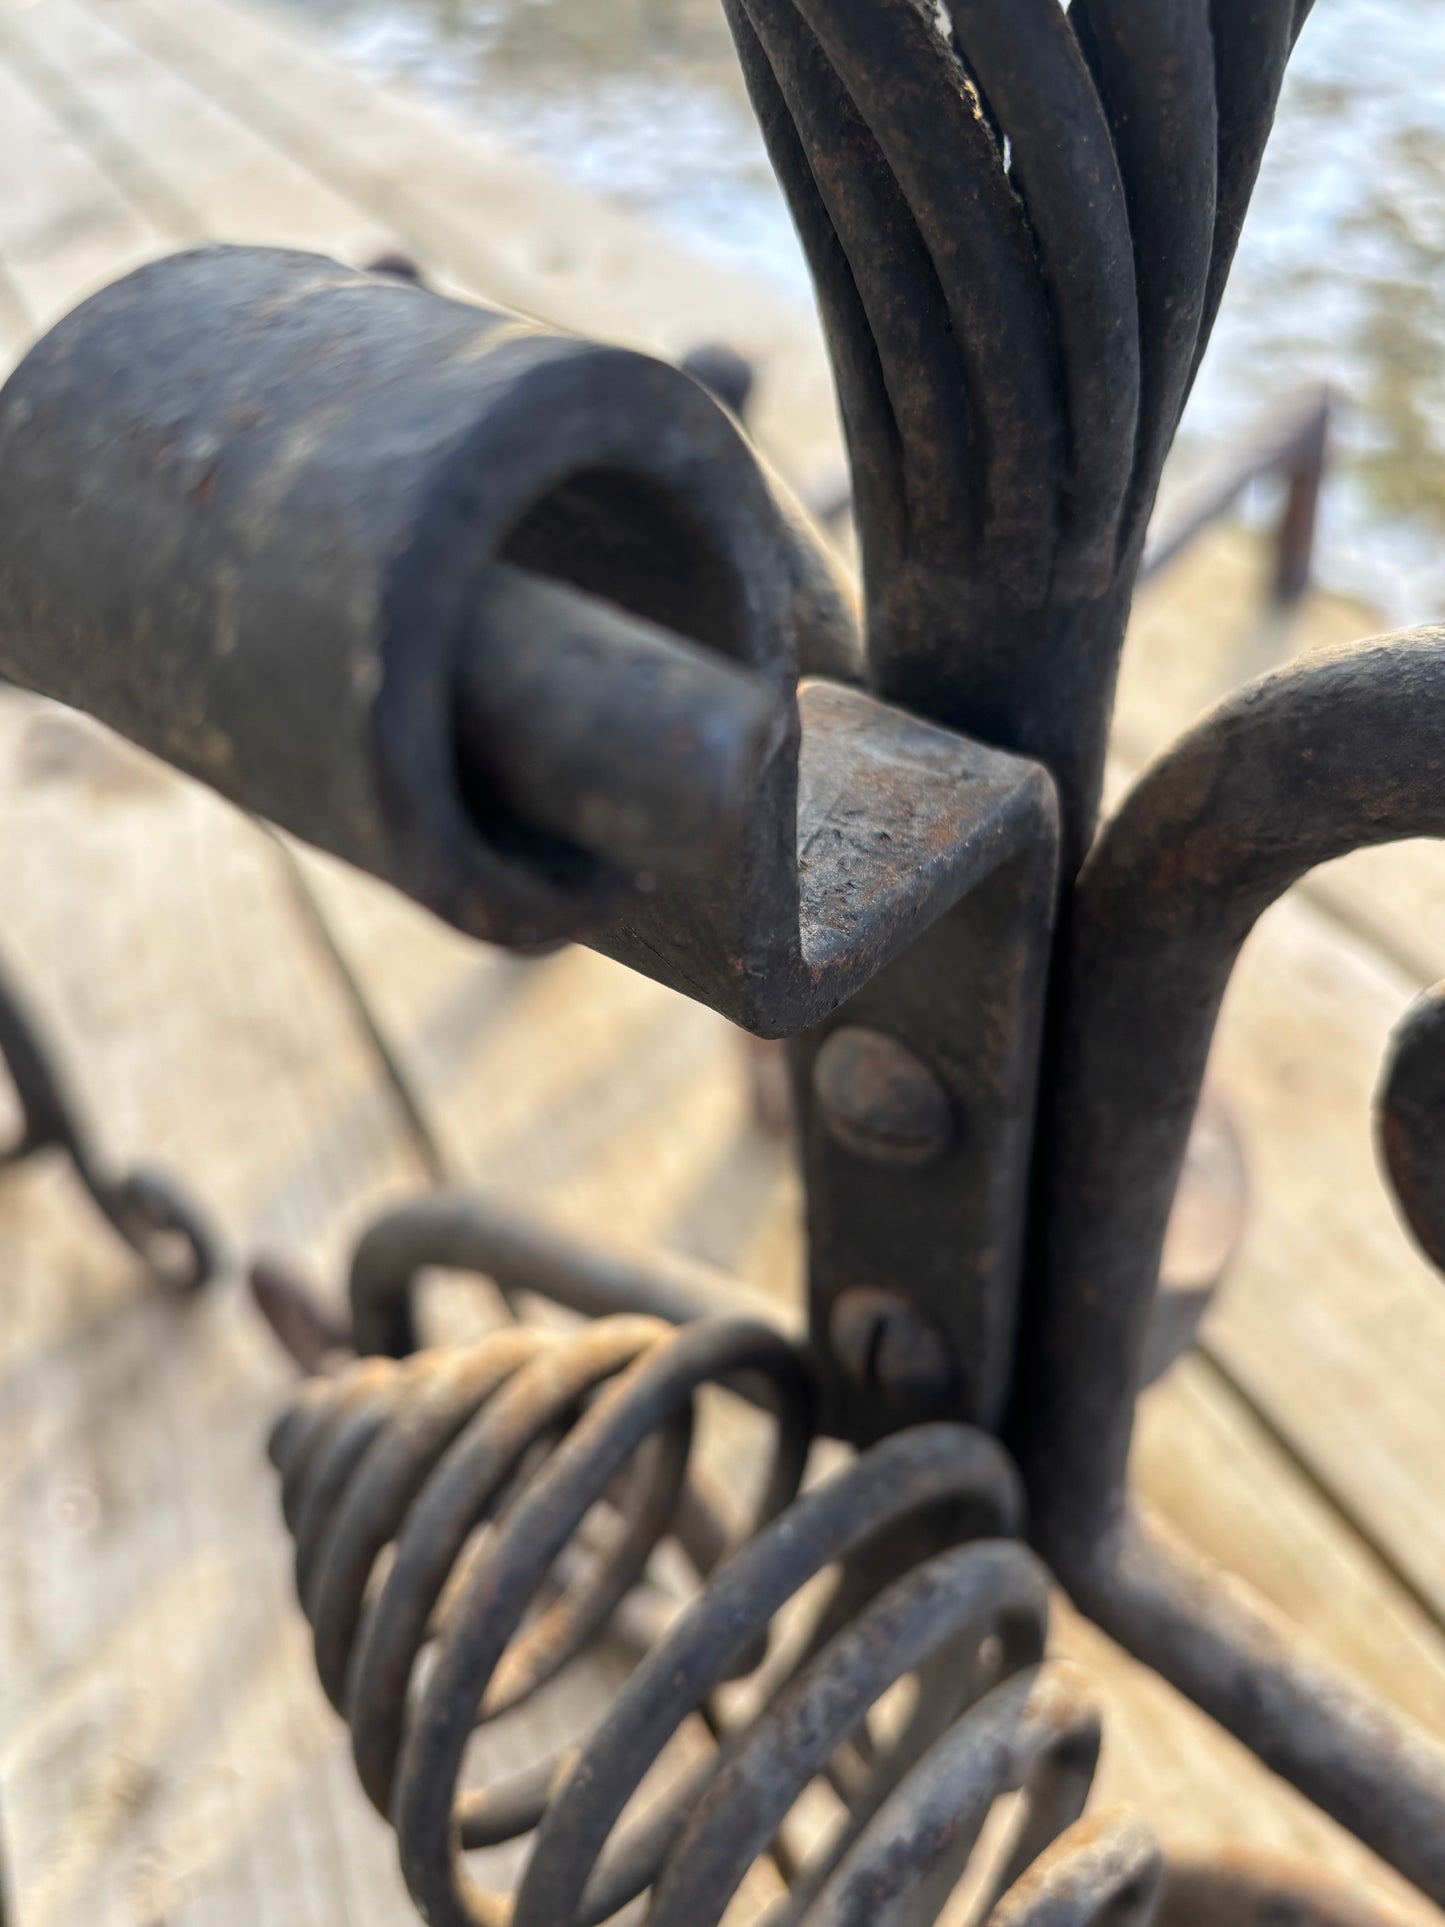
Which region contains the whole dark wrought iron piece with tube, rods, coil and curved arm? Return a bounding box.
[0,0,1445,1927]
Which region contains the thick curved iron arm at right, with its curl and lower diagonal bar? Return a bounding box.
[1012,628,1445,1900]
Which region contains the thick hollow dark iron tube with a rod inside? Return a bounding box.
[0,249,852,942]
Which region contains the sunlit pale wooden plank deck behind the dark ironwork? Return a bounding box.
[0,0,1445,1927]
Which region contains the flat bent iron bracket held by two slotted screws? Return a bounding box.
[790,682,1058,1439]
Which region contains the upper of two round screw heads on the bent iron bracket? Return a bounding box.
[813,1023,958,1166]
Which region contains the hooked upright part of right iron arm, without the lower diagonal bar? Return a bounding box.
[1015,628,1445,1549]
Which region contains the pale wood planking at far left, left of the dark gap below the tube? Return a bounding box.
[0,696,433,1927]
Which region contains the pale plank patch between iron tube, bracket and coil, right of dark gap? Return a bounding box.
[287,854,801,1291]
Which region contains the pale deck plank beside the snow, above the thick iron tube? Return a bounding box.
[85,0,840,476]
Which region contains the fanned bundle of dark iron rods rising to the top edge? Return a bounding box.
[724,0,1308,859]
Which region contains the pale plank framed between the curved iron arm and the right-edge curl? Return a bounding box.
[1210,902,1445,1615]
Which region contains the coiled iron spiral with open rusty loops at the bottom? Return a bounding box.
[272,1316,1394,1927]
